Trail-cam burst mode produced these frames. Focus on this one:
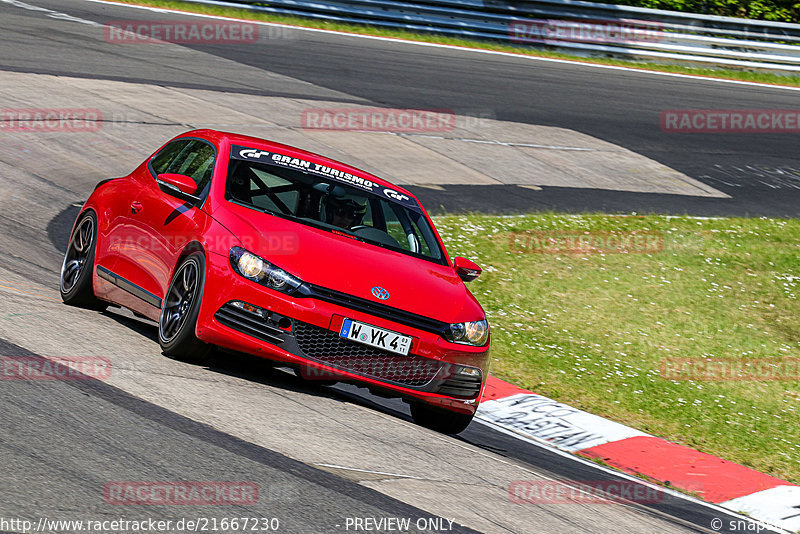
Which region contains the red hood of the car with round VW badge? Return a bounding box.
[214,203,485,323]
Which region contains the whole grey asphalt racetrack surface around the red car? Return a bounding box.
[0,0,800,534]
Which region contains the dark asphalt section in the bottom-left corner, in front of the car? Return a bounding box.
[0,339,474,532]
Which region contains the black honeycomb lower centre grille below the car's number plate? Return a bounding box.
[294,321,441,386]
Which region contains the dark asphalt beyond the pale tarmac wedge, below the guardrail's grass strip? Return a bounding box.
[0,0,800,216]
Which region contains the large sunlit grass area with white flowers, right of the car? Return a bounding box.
[436,214,800,483]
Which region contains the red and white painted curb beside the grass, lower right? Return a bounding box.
[475,375,800,532]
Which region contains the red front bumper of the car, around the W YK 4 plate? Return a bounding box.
[197,254,488,414]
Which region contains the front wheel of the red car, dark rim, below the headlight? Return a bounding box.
[158,252,213,363]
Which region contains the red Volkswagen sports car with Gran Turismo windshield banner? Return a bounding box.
[61,130,489,434]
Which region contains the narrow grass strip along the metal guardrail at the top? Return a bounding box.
[106,0,800,86]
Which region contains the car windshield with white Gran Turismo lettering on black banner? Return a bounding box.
[225,146,444,264]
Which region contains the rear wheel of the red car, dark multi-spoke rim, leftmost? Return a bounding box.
[59,211,107,310]
